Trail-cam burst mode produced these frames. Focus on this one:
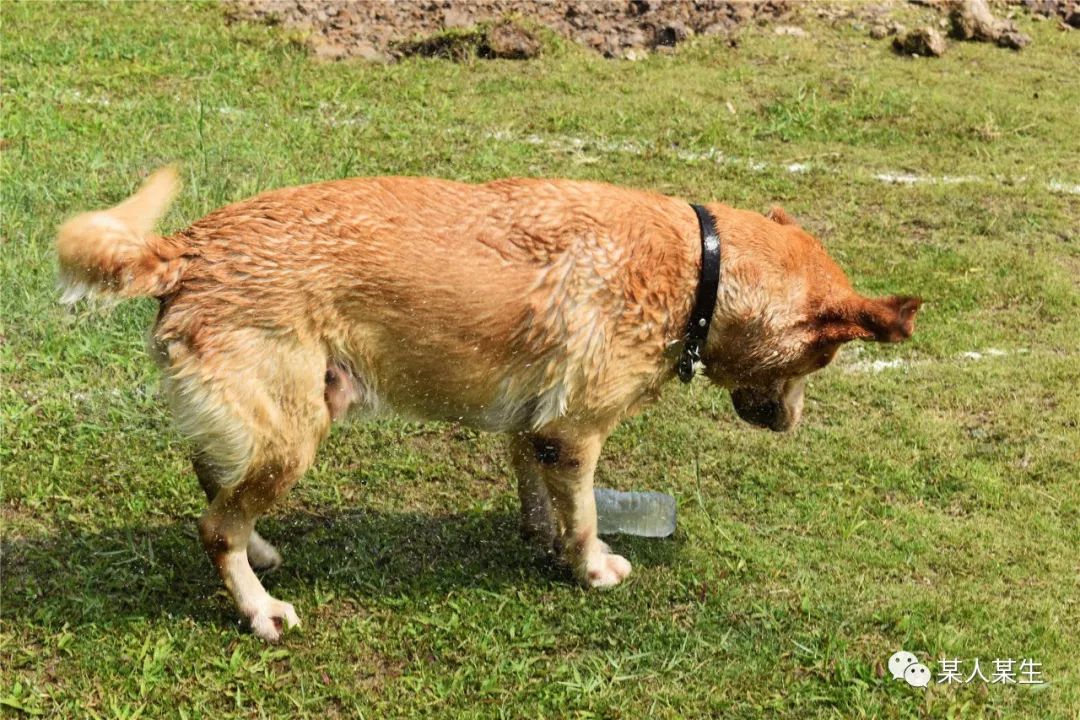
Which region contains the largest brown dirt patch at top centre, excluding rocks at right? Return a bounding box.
[225,0,796,62]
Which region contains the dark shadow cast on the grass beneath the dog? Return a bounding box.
[0,510,679,627]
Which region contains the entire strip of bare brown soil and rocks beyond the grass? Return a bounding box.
[222,0,1080,62]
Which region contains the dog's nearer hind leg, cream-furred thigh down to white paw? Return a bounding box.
[171,337,330,641]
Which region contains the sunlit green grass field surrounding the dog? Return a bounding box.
[0,2,1080,719]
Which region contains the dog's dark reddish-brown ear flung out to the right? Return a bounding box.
[813,295,922,344]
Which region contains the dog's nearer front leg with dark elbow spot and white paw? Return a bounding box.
[531,434,631,587]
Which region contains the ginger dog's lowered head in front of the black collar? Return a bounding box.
[702,206,922,432]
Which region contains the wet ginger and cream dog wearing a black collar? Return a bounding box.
[57,168,921,641]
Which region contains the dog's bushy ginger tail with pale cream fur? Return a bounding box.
[56,167,188,303]
